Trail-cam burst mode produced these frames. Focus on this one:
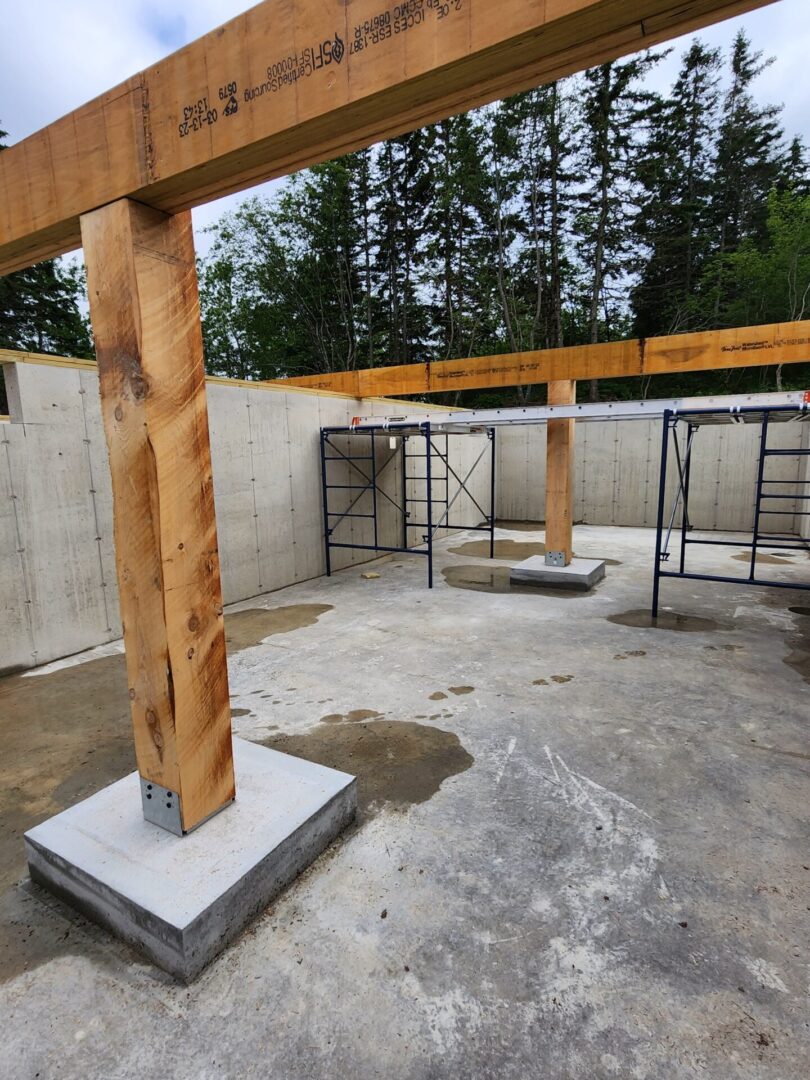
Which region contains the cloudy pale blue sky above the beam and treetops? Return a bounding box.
[0,0,810,259]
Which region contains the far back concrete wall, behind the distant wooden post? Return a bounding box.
[498,420,810,535]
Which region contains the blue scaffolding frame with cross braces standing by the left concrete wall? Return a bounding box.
[321,422,496,589]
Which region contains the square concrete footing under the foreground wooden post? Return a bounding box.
[25,739,356,982]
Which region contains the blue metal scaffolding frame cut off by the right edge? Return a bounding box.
[652,401,810,619]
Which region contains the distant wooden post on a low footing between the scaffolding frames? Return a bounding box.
[545,379,577,566]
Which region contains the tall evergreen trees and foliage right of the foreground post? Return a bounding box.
[201,33,810,404]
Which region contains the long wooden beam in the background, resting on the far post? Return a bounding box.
[278,320,810,397]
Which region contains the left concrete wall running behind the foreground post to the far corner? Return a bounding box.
[0,364,488,671]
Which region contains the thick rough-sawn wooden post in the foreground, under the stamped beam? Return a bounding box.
[81,199,234,833]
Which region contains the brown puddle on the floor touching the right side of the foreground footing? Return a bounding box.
[262,720,474,822]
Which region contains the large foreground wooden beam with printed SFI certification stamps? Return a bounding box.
[0,0,773,273]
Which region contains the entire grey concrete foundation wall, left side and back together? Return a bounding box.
[0,364,810,671]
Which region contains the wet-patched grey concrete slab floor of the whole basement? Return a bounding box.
[0,526,810,1080]
